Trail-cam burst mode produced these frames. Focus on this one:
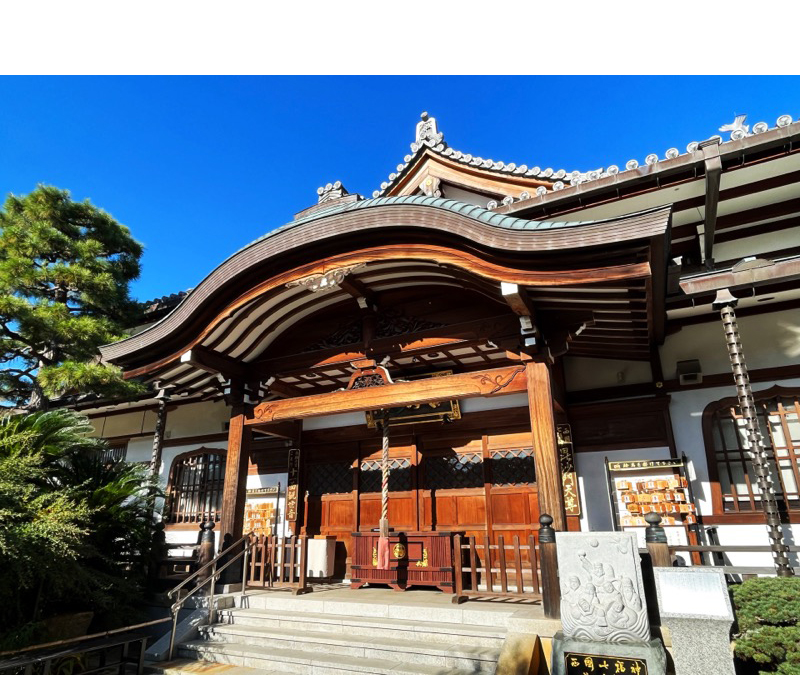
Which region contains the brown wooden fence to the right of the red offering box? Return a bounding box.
[453,534,542,602]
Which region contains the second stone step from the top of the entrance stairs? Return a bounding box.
[217,609,506,647]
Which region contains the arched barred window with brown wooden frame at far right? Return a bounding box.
[703,387,800,515]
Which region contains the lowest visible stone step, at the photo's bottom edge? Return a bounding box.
[178,640,488,675]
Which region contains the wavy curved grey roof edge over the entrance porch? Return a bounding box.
[101,195,670,372]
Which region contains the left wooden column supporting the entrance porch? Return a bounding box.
[220,403,252,542]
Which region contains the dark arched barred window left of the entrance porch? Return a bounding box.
[167,448,225,524]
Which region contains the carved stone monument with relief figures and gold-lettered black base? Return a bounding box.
[552,532,666,675]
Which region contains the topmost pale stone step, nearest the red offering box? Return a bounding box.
[236,591,520,628]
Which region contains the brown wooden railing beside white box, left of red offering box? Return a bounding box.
[247,535,310,595]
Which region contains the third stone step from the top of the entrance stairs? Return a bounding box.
[200,624,500,673]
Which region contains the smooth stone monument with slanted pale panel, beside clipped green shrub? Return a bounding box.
[653,567,734,675]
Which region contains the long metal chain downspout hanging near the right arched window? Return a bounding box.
[712,288,794,577]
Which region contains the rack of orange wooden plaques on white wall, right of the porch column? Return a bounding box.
[605,455,697,544]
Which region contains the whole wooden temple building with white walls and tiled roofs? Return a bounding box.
[84,113,800,578]
